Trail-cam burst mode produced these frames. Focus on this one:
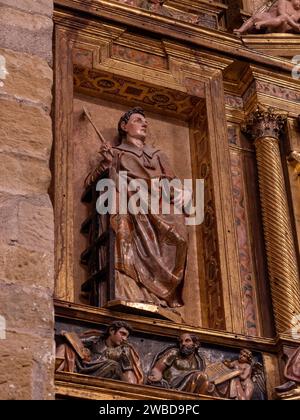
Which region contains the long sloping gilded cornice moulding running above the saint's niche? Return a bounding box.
[54,0,294,74]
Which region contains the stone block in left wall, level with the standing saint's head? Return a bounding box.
[0,99,52,159]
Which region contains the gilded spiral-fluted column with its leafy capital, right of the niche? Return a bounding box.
[244,107,300,333]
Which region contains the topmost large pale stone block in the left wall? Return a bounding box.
[0,6,53,63]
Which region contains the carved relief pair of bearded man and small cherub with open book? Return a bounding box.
[147,333,266,400]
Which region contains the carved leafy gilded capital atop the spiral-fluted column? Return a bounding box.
[242,105,287,140]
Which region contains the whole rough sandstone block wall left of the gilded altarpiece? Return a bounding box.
[0,0,54,399]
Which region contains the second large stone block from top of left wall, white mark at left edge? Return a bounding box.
[0,48,53,110]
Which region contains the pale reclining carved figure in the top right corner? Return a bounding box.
[234,0,300,35]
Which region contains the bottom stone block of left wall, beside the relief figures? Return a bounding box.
[0,331,54,400]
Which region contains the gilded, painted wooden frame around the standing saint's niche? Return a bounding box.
[55,4,234,329]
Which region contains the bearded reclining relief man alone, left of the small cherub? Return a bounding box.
[147,333,211,394]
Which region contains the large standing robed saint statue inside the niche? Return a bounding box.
[87,108,188,309]
